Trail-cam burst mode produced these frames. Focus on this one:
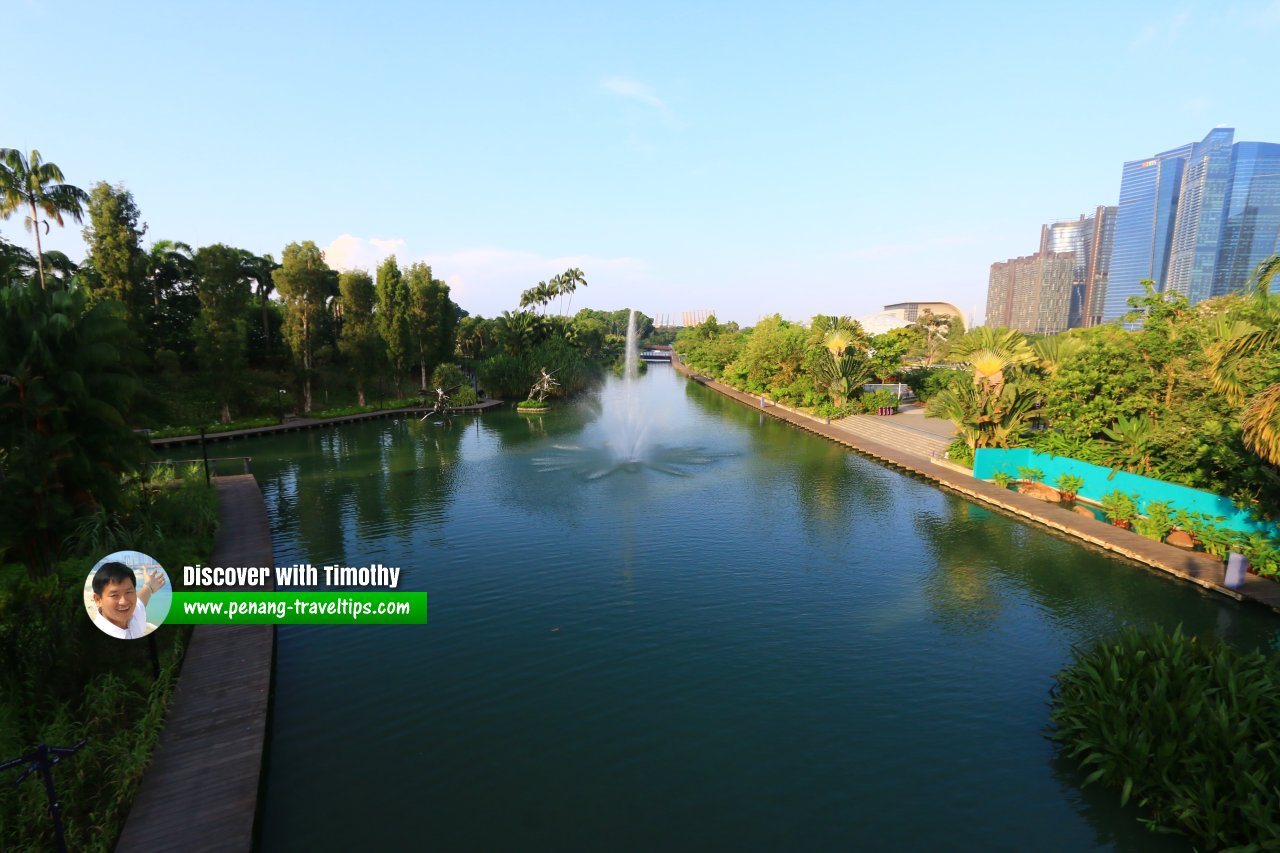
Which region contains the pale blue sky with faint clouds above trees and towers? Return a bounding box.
[0,0,1280,324]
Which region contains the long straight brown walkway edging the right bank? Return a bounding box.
[672,359,1280,612]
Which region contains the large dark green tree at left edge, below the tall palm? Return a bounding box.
[0,283,148,573]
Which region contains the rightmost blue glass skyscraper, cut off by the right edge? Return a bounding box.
[1210,142,1280,296]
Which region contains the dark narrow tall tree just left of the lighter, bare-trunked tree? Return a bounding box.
[196,243,250,424]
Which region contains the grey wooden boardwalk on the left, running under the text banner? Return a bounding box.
[115,474,275,853]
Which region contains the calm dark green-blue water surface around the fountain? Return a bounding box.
[225,366,1280,850]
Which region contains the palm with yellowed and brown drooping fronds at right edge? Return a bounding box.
[1213,255,1280,465]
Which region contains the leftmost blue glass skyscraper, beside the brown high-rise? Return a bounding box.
[1102,142,1194,321]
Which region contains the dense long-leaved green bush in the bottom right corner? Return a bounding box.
[1050,626,1280,849]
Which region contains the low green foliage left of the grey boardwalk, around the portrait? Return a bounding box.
[0,467,218,850]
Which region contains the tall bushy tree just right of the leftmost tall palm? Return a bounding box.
[83,181,147,317]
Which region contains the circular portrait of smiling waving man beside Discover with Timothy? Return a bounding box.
[84,551,173,639]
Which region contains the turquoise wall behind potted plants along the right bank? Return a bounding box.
[973,447,1277,537]
